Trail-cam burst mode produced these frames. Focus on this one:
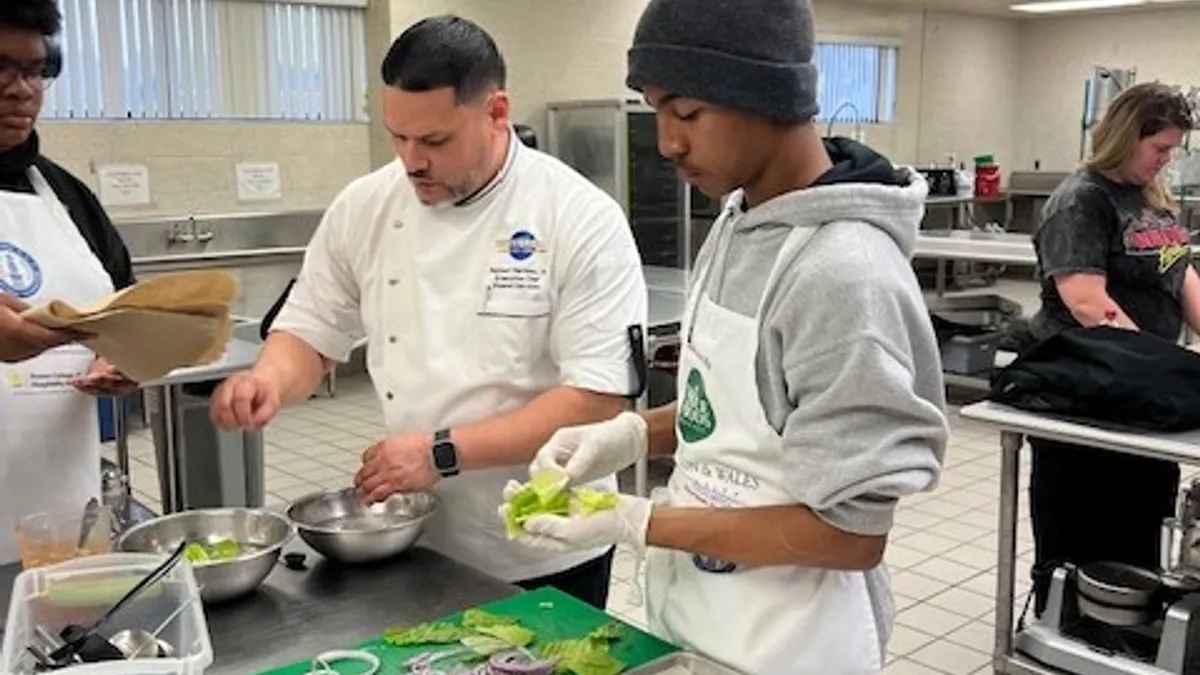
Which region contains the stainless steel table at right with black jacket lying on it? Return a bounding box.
[959,401,1200,675]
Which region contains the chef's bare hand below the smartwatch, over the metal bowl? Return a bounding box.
[354,434,440,504]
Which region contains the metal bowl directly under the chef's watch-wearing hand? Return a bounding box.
[288,488,438,563]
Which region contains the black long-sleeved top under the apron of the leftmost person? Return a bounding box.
[0,133,134,289]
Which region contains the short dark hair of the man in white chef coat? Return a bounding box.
[379,14,506,103]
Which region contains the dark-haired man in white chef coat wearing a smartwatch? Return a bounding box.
[212,16,647,608]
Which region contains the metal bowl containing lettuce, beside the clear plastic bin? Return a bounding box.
[116,508,295,603]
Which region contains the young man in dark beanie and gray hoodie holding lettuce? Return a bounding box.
[502,0,948,675]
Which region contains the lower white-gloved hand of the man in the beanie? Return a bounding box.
[499,483,654,552]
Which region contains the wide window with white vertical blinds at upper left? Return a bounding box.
[43,0,367,121]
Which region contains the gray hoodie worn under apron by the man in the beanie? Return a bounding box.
[701,139,949,641]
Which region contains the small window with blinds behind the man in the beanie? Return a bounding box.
[816,40,900,124]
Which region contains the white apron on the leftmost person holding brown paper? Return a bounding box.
[0,167,113,565]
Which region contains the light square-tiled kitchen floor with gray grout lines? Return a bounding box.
[108,275,1056,675]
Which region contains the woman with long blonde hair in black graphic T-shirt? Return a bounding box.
[1030,83,1200,614]
